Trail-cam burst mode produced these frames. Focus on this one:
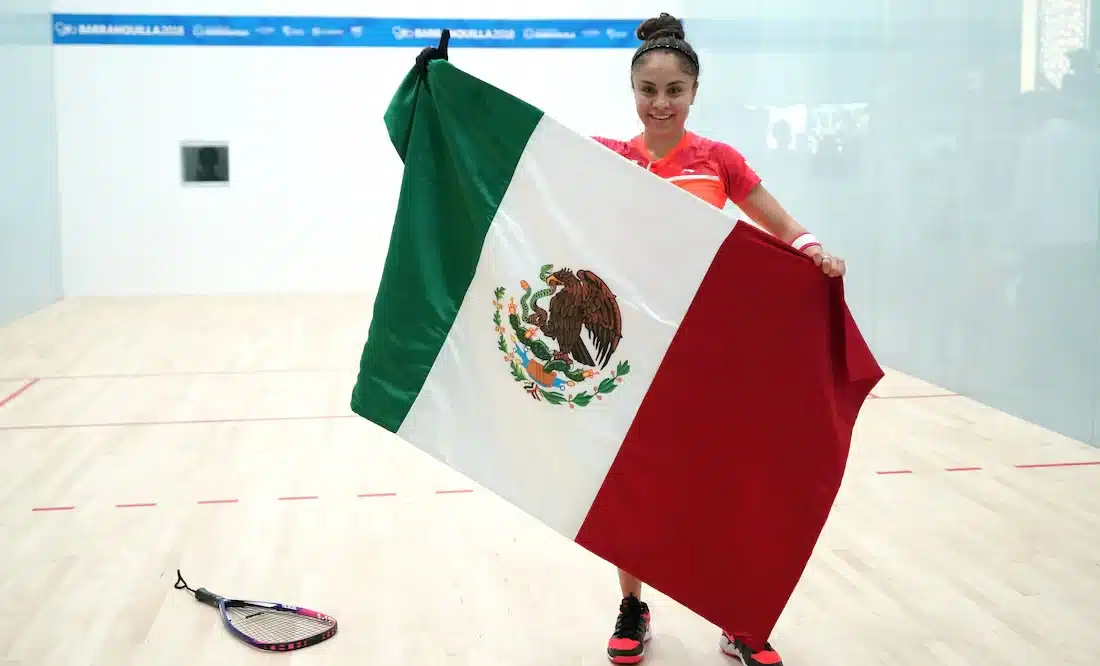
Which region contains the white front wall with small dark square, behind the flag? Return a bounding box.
[54,0,679,296]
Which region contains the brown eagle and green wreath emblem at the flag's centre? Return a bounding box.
[493,264,630,408]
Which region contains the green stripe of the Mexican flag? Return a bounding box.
[351,61,542,433]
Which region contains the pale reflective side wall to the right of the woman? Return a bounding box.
[684,0,1100,444]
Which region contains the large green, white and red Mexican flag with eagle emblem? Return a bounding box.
[351,61,882,643]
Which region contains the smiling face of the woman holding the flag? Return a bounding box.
[631,51,696,135]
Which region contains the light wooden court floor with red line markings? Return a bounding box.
[0,296,1100,666]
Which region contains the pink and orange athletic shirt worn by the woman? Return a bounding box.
[593,132,760,208]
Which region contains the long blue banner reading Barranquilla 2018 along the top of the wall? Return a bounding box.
[53,14,641,48]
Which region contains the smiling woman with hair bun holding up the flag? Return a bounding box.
[593,13,845,666]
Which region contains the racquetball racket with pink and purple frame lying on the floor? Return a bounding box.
[174,569,337,652]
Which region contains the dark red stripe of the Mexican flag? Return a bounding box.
[576,222,883,647]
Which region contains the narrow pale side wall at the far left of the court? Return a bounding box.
[0,0,62,326]
